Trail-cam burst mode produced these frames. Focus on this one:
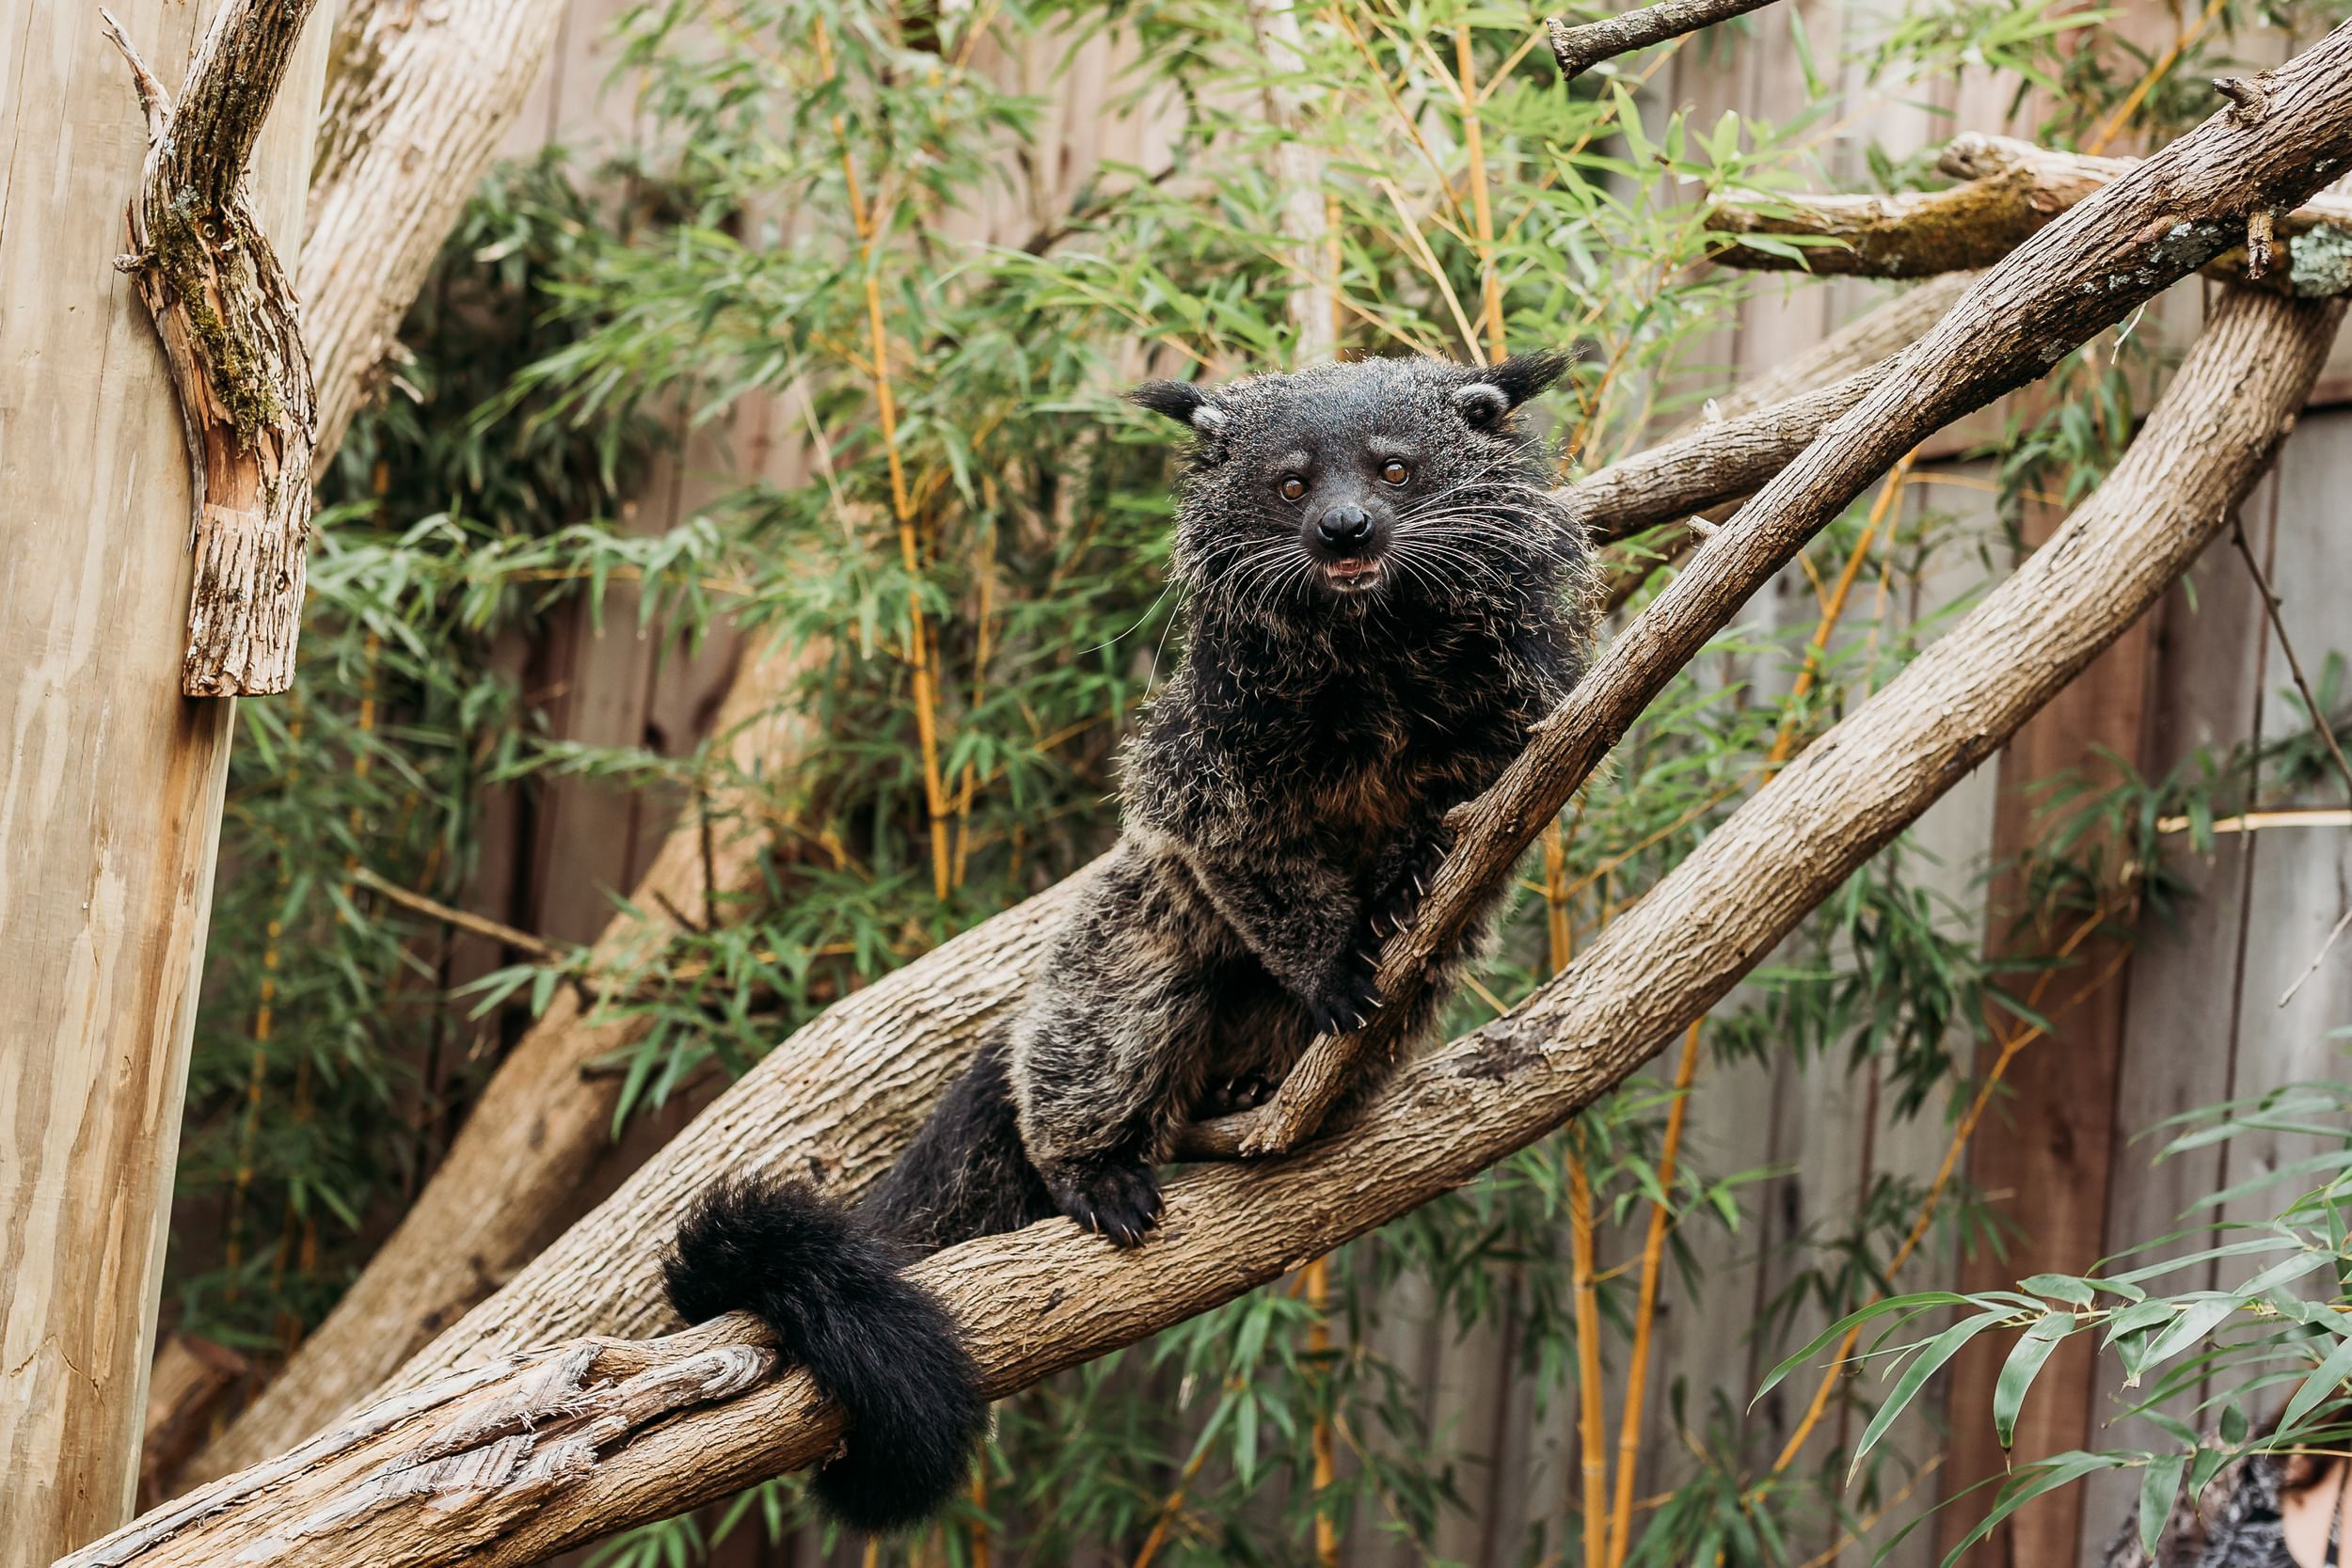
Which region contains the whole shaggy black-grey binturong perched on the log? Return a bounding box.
[663,355,1590,1530]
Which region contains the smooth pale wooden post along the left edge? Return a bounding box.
[0,0,327,1563]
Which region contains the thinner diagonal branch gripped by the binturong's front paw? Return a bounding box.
[1202,24,2352,1154]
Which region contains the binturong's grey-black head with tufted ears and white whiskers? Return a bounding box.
[1129,353,1583,623]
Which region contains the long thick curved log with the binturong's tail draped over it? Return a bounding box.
[61,278,2343,1568]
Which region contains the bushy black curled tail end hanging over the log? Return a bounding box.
[661,1178,988,1530]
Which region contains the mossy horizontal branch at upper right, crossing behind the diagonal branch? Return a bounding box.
[1708,127,2352,298]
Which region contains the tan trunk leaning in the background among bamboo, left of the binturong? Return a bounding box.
[179,649,812,1486]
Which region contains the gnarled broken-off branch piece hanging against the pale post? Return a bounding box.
[102,0,315,696]
